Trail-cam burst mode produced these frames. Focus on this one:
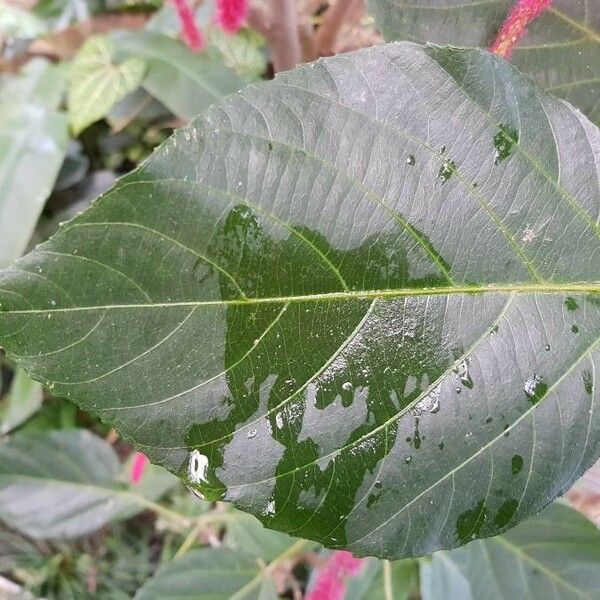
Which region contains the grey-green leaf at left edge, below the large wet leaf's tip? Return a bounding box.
[0,430,172,539]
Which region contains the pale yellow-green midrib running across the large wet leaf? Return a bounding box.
[0,282,600,318]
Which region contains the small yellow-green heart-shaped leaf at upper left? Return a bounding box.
[69,36,146,134]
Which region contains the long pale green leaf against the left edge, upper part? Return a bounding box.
[0,59,68,267]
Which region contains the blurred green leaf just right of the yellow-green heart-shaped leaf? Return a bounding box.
[111,31,243,120]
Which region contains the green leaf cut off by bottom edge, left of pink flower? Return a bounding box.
[135,548,264,600]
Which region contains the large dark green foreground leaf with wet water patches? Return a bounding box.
[0,43,600,557]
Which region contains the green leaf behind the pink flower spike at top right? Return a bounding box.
[369,0,600,123]
